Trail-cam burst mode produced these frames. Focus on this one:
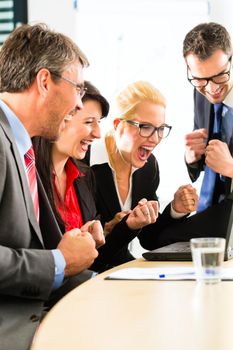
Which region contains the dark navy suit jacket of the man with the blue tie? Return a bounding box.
[187,89,233,204]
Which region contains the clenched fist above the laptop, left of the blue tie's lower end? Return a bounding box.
[172,185,198,213]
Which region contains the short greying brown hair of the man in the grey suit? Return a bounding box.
[0,24,89,92]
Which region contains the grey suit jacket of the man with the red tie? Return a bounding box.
[0,110,61,350]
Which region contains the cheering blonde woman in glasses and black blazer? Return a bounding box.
[92,81,198,265]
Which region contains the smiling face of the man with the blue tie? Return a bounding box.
[186,50,233,103]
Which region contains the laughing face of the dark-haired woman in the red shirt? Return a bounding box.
[54,100,102,159]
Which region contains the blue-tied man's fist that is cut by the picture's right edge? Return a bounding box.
[205,140,233,178]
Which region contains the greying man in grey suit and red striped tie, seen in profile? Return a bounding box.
[0,25,97,350]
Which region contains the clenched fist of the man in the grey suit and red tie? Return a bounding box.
[57,229,98,276]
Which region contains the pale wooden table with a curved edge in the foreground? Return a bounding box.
[31,259,233,350]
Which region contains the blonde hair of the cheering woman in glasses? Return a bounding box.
[105,80,166,169]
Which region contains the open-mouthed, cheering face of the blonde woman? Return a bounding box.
[114,101,165,168]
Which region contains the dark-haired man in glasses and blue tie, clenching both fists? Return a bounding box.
[142,23,233,248]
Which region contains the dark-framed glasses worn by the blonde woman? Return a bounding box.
[123,119,172,139]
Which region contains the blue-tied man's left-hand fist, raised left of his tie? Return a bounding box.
[185,129,208,164]
